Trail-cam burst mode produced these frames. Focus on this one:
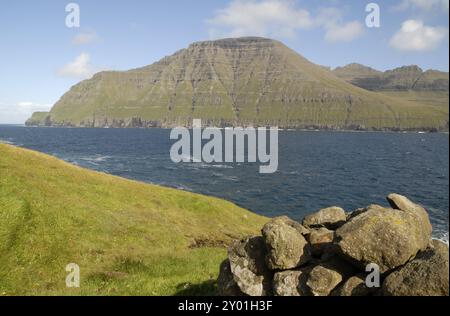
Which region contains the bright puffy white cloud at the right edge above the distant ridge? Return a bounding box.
[390,20,448,51]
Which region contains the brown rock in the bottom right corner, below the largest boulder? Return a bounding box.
[382,240,449,296]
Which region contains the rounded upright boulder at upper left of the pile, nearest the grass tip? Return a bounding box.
[262,217,311,270]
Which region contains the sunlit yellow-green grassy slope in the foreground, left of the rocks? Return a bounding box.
[0,144,266,295]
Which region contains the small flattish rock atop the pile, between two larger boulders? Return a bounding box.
[303,206,347,229]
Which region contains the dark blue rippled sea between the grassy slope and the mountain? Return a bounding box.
[0,125,449,241]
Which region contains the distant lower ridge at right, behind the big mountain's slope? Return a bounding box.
[333,64,449,93]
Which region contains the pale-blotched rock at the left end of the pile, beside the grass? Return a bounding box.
[228,237,273,296]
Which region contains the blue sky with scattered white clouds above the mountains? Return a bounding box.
[0,0,449,124]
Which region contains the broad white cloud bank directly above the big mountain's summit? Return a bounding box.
[207,0,363,42]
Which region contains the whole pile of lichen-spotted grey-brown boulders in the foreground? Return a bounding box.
[218,194,449,296]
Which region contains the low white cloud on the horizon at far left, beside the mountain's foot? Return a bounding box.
[0,101,52,124]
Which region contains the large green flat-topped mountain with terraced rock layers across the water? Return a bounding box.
[27,37,448,130]
